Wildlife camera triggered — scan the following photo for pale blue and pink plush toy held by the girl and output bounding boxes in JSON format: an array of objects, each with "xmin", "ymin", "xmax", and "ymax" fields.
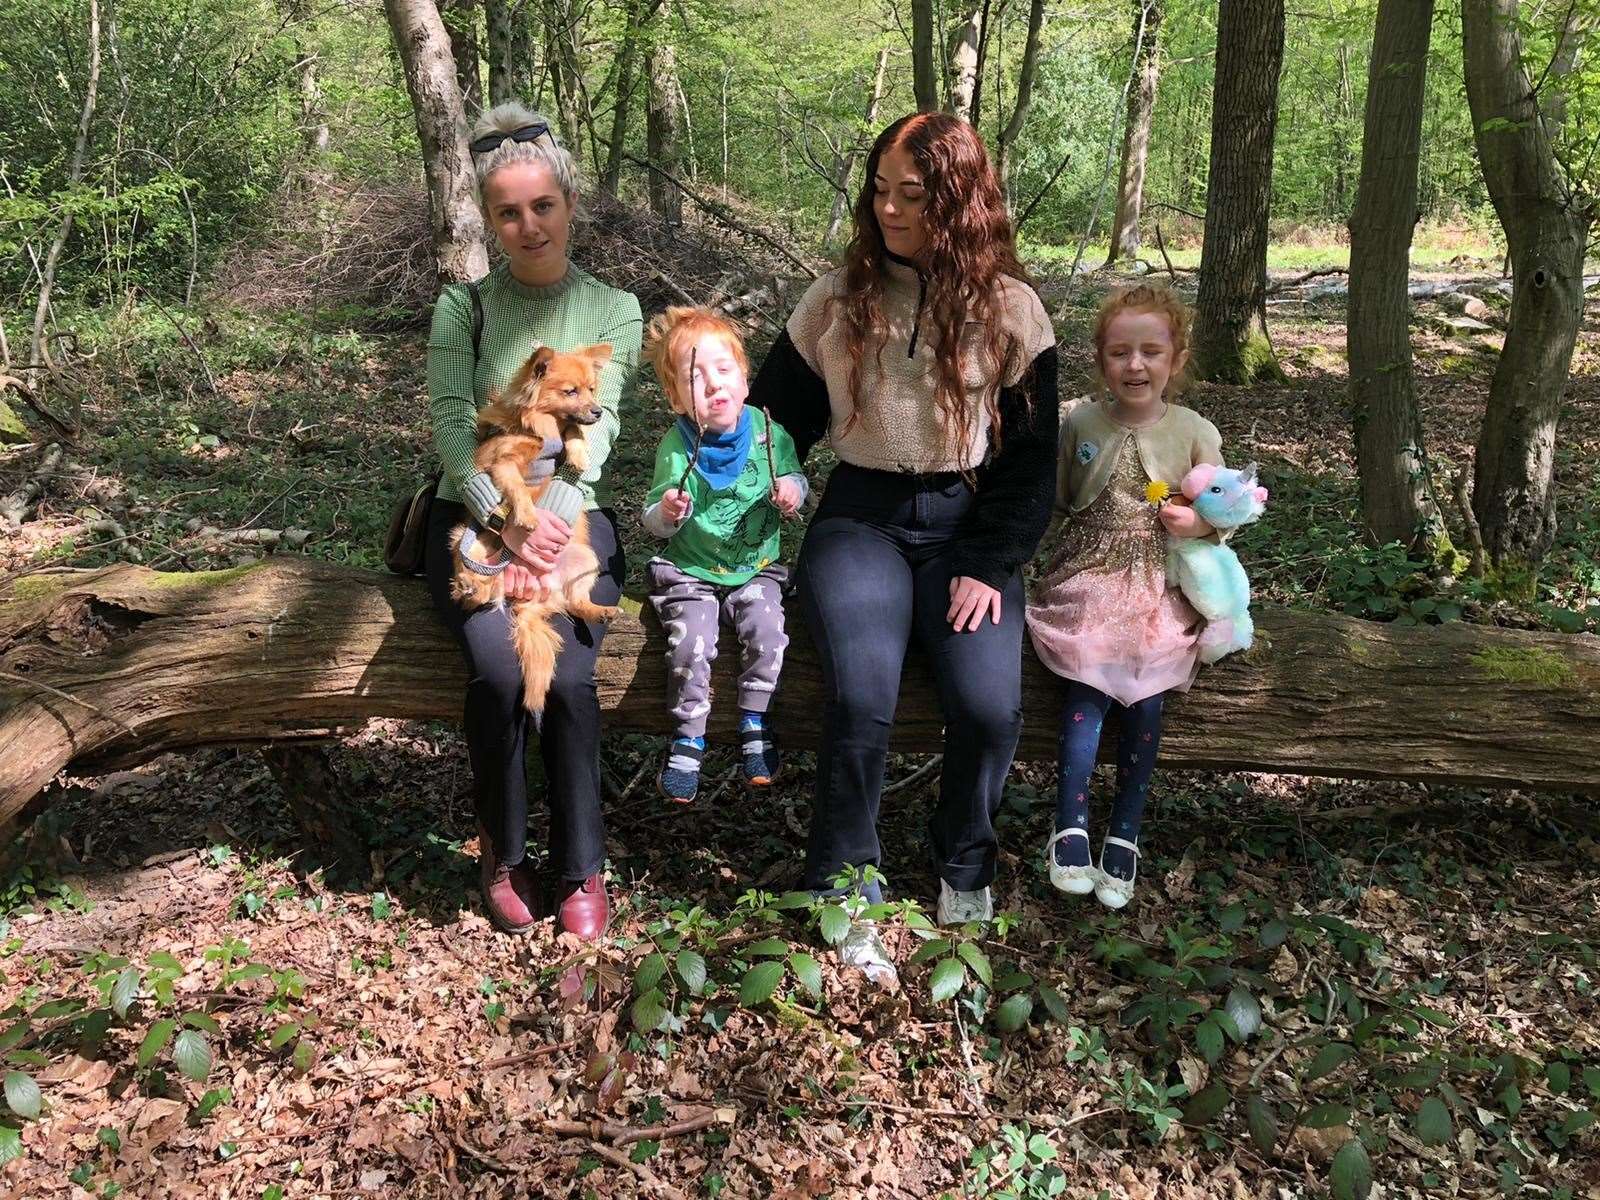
[{"xmin": 1166, "ymin": 462, "xmax": 1267, "ymax": 662}]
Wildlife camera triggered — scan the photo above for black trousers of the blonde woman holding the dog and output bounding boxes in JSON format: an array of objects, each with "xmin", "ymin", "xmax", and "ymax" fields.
[{"xmin": 427, "ymin": 499, "xmax": 627, "ymax": 880}]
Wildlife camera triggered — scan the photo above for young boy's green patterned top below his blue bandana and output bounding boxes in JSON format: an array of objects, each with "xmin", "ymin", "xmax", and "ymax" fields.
[{"xmin": 645, "ymin": 408, "xmax": 800, "ymax": 586}]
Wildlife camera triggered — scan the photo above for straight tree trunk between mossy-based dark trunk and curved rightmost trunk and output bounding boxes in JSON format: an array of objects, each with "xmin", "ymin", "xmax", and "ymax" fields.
[{"xmin": 1349, "ymin": 0, "xmax": 1440, "ymax": 549}]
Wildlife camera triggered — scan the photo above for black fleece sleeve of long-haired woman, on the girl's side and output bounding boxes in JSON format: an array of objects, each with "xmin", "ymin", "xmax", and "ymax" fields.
[{"xmin": 950, "ymin": 346, "xmax": 1061, "ymax": 587}]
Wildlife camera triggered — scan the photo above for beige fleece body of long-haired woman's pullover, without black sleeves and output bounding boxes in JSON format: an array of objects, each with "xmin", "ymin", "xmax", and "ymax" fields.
[{"xmin": 787, "ymin": 262, "xmax": 1056, "ymax": 474}]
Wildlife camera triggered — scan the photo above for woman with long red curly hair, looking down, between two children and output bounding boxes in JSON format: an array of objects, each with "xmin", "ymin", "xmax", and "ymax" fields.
[{"xmin": 750, "ymin": 114, "xmax": 1058, "ymax": 978}]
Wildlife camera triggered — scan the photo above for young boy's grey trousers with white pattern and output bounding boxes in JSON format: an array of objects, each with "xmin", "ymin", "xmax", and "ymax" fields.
[{"xmin": 645, "ymin": 558, "xmax": 789, "ymax": 738}]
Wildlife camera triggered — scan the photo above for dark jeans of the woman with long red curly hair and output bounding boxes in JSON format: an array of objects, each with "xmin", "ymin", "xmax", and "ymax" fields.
[{"xmin": 798, "ymin": 464, "xmax": 1022, "ymax": 891}]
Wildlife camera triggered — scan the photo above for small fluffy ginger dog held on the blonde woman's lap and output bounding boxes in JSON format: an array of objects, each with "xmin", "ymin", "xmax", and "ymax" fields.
[{"xmin": 450, "ymin": 342, "xmax": 618, "ymax": 712}]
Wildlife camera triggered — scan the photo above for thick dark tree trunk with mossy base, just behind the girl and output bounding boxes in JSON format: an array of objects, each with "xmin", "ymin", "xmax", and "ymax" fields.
[{"xmin": 1194, "ymin": 0, "xmax": 1283, "ymax": 384}]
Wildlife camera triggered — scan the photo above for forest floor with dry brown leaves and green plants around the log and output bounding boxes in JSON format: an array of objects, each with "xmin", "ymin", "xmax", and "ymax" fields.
[{"xmin": 0, "ymin": 227, "xmax": 1600, "ymax": 1200}]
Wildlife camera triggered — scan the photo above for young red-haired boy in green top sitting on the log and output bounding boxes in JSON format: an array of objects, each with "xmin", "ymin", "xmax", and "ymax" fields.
[{"xmin": 643, "ymin": 307, "xmax": 808, "ymax": 803}]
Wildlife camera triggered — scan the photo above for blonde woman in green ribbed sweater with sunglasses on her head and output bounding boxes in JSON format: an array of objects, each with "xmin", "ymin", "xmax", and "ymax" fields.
[{"xmin": 427, "ymin": 104, "xmax": 643, "ymax": 939}]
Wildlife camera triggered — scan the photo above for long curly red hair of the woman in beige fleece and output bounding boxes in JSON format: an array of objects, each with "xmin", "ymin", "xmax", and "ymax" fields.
[{"xmin": 840, "ymin": 112, "xmax": 1029, "ymax": 464}]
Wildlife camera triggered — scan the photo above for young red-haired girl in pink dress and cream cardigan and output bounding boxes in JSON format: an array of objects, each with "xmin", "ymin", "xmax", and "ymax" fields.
[{"xmin": 1027, "ymin": 285, "xmax": 1222, "ymax": 909}]
